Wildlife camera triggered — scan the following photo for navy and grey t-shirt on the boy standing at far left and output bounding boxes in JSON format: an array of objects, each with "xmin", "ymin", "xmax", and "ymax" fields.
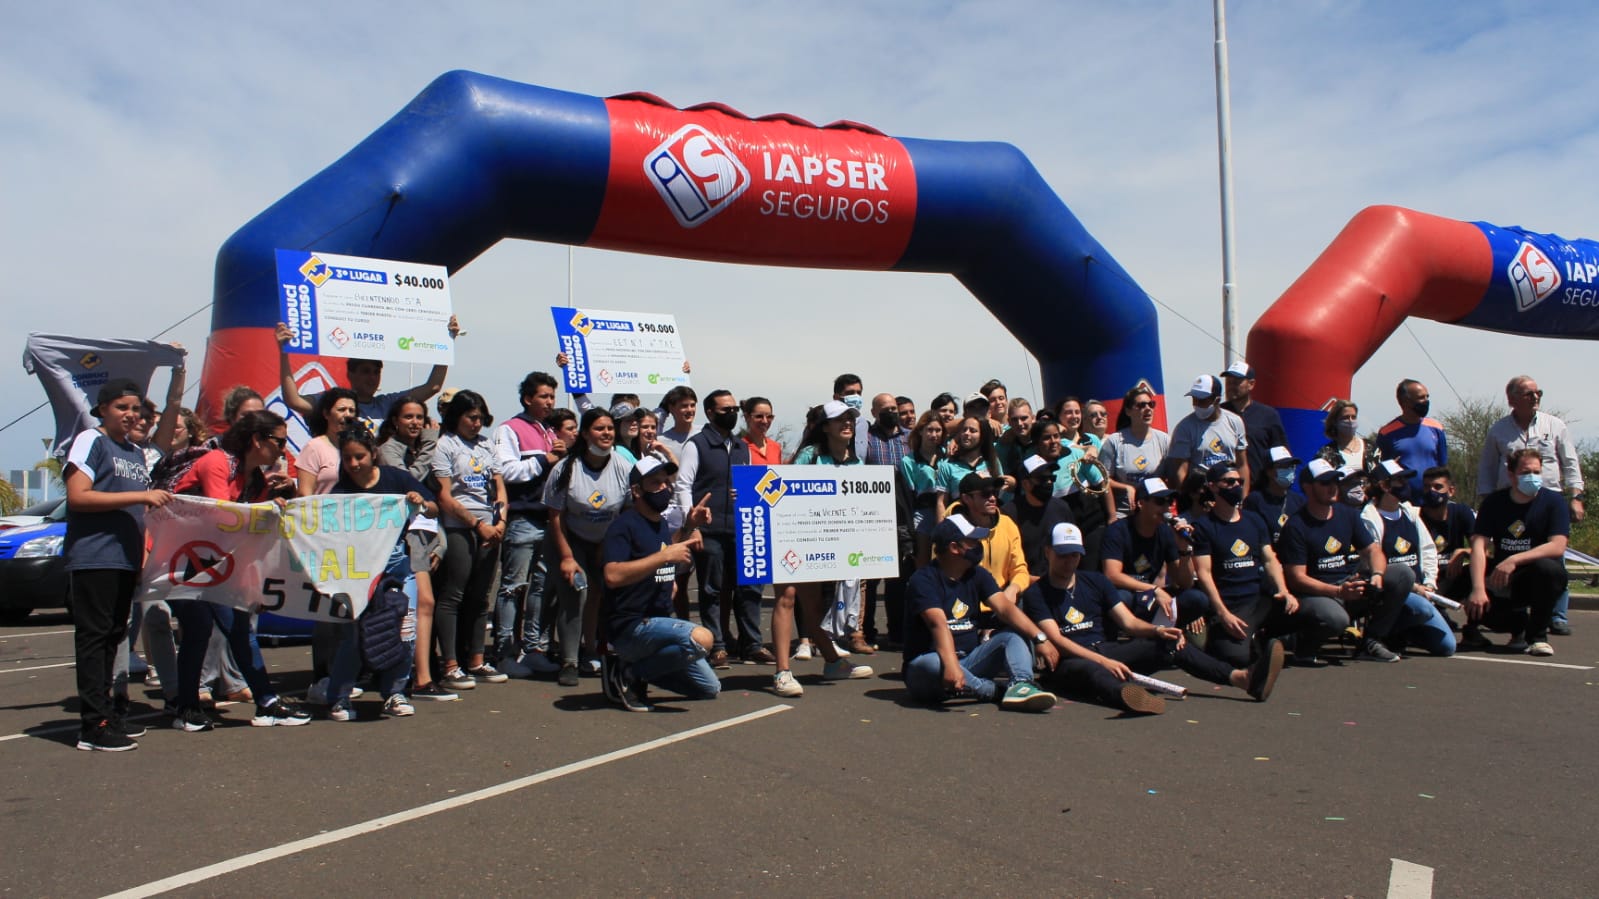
[{"xmin": 61, "ymin": 429, "xmax": 150, "ymax": 571}]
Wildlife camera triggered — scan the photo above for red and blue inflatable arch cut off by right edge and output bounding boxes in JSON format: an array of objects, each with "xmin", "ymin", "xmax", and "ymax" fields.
[{"xmin": 1249, "ymin": 206, "xmax": 1599, "ymax": 457}]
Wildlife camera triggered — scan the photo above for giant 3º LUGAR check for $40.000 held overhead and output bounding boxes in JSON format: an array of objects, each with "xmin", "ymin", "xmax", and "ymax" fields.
[{"xmin": 278, "ymin": 250, "xmax": 456, "ymax": 365}]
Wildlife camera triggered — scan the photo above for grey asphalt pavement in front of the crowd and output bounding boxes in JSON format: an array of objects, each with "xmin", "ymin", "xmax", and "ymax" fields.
[{"xmin": 0, "ymin": 609, "xmax": 1599, "ymax": 899}]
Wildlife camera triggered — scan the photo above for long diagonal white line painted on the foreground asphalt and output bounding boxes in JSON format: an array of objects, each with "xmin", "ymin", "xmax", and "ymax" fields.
[{"xmin": 106, "ymin": 705, "xmax": 792, "ymax": 899}]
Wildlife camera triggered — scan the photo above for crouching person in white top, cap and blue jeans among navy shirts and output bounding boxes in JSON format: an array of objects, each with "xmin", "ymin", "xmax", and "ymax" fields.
[{"xmin": 1361, "ymin": 459, "xmax": 1455, "ymax": 657}]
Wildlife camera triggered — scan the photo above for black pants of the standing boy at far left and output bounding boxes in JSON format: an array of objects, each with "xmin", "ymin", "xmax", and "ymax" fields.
[{"xmin": 67, "ymin": 568, "xmax": 135, "ymax": 728}]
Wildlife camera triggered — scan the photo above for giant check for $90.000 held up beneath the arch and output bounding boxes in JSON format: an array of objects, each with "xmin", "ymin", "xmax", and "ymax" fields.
[{"xmin": 550, "ymin": 306, "xmax": 689, "ymax": 394}]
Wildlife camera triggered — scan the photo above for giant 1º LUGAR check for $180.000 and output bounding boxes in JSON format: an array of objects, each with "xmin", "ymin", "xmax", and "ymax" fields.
[{"xmin": 732, "ymin": 465, "xmax": 899, "ymax": 584}]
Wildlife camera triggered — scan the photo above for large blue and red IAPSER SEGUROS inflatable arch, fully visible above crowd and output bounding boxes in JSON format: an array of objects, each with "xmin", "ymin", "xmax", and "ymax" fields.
[{"xmin": 201, "ymin": 72, "xmax": 1162, "ymax": 435}]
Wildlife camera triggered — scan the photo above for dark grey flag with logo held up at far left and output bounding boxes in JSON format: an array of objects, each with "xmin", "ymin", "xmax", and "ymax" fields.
[{"xmin": 22, "ymin": 333, "xmax": 184, "ymax": 457}]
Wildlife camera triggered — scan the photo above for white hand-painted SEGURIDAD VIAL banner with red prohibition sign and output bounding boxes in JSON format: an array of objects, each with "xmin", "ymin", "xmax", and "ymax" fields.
[{"xmin": 139, "ymin": 493, "xmax": 413, "ymax": 621}]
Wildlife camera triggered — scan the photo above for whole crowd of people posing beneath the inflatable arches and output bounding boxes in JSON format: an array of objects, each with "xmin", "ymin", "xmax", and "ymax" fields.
[{"xmin": 64, "ymin": 320, "xmax": 1583, "ymax": 750}]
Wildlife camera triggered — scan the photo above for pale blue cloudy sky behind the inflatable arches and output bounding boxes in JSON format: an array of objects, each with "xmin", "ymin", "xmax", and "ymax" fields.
[{"xmin": 0, "ymin": 0, "xmax": 1599, "ymax": 469}]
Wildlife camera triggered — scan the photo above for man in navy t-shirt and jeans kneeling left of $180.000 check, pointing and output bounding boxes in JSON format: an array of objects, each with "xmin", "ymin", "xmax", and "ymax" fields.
[{"xmin": 600, "ymin": 454, "xmax": 716, "ymax": 712}]
